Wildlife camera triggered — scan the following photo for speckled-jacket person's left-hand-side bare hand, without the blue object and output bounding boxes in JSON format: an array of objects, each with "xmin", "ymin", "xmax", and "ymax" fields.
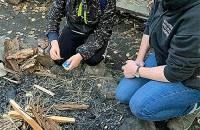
[{"xmin": 50, "ymin": 40, "xmax": 61, "ymax": 60}]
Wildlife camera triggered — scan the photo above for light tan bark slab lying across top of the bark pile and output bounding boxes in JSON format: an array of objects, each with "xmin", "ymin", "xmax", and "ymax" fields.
[{"xmin": 6, "ymin": 48, "xmax": 38, "ymax": 60}]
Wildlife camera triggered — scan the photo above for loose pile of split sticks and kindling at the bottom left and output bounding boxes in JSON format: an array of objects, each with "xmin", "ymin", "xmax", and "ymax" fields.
[{"xmin": 4, "ymin": 85, "xmax": 89, "ymax": 130}]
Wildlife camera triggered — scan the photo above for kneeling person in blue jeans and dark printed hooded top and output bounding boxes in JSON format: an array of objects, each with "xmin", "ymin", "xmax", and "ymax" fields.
[{"xmin": 116, "ymin": 0, "xmax": 200, "ymax": 130}]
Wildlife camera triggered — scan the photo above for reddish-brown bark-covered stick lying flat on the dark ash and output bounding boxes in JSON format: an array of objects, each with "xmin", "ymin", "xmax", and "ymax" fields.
[{"xmin": 54, "ymin": 103, "xmax": 89, "ymax": 111}]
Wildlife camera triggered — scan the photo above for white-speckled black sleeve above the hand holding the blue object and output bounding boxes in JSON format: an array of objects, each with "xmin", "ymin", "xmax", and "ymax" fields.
[{"xmin": 77, "ymin": 0, "xmax": 116, "ymax": 60}]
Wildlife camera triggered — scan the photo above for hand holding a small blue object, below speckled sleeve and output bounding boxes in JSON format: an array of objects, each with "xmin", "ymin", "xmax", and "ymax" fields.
[{"xmin": 66, "ymin": 53, "xmax": 83, "ymax": 71}]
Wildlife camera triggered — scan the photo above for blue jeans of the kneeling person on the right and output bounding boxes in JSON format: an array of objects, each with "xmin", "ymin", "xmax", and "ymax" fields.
[{"xmin": 116, "ymin": 54, "xmax": 200, "ymax": 121}]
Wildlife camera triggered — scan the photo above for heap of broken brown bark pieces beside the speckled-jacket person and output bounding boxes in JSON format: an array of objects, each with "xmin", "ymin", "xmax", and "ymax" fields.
[{"xmin": 1, "ymin": 38, "xmax": 54, "ymax": 80}]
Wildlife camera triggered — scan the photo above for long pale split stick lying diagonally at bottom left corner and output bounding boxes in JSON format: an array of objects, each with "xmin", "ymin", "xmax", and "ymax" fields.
[{"xmin": 10, "ymin": 100, "xmax": 43, "ymax": 130}]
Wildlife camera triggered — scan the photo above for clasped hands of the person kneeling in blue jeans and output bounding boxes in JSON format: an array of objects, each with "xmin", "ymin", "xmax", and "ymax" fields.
[{"xmin": 122, "ymin": 60, "xmax": 138, "ymax": 78}]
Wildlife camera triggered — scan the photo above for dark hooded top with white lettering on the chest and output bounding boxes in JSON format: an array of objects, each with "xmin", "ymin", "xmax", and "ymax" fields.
[{"xmin": 144, "ymin": 0, "xmax": 200, "ymax": 89}]
